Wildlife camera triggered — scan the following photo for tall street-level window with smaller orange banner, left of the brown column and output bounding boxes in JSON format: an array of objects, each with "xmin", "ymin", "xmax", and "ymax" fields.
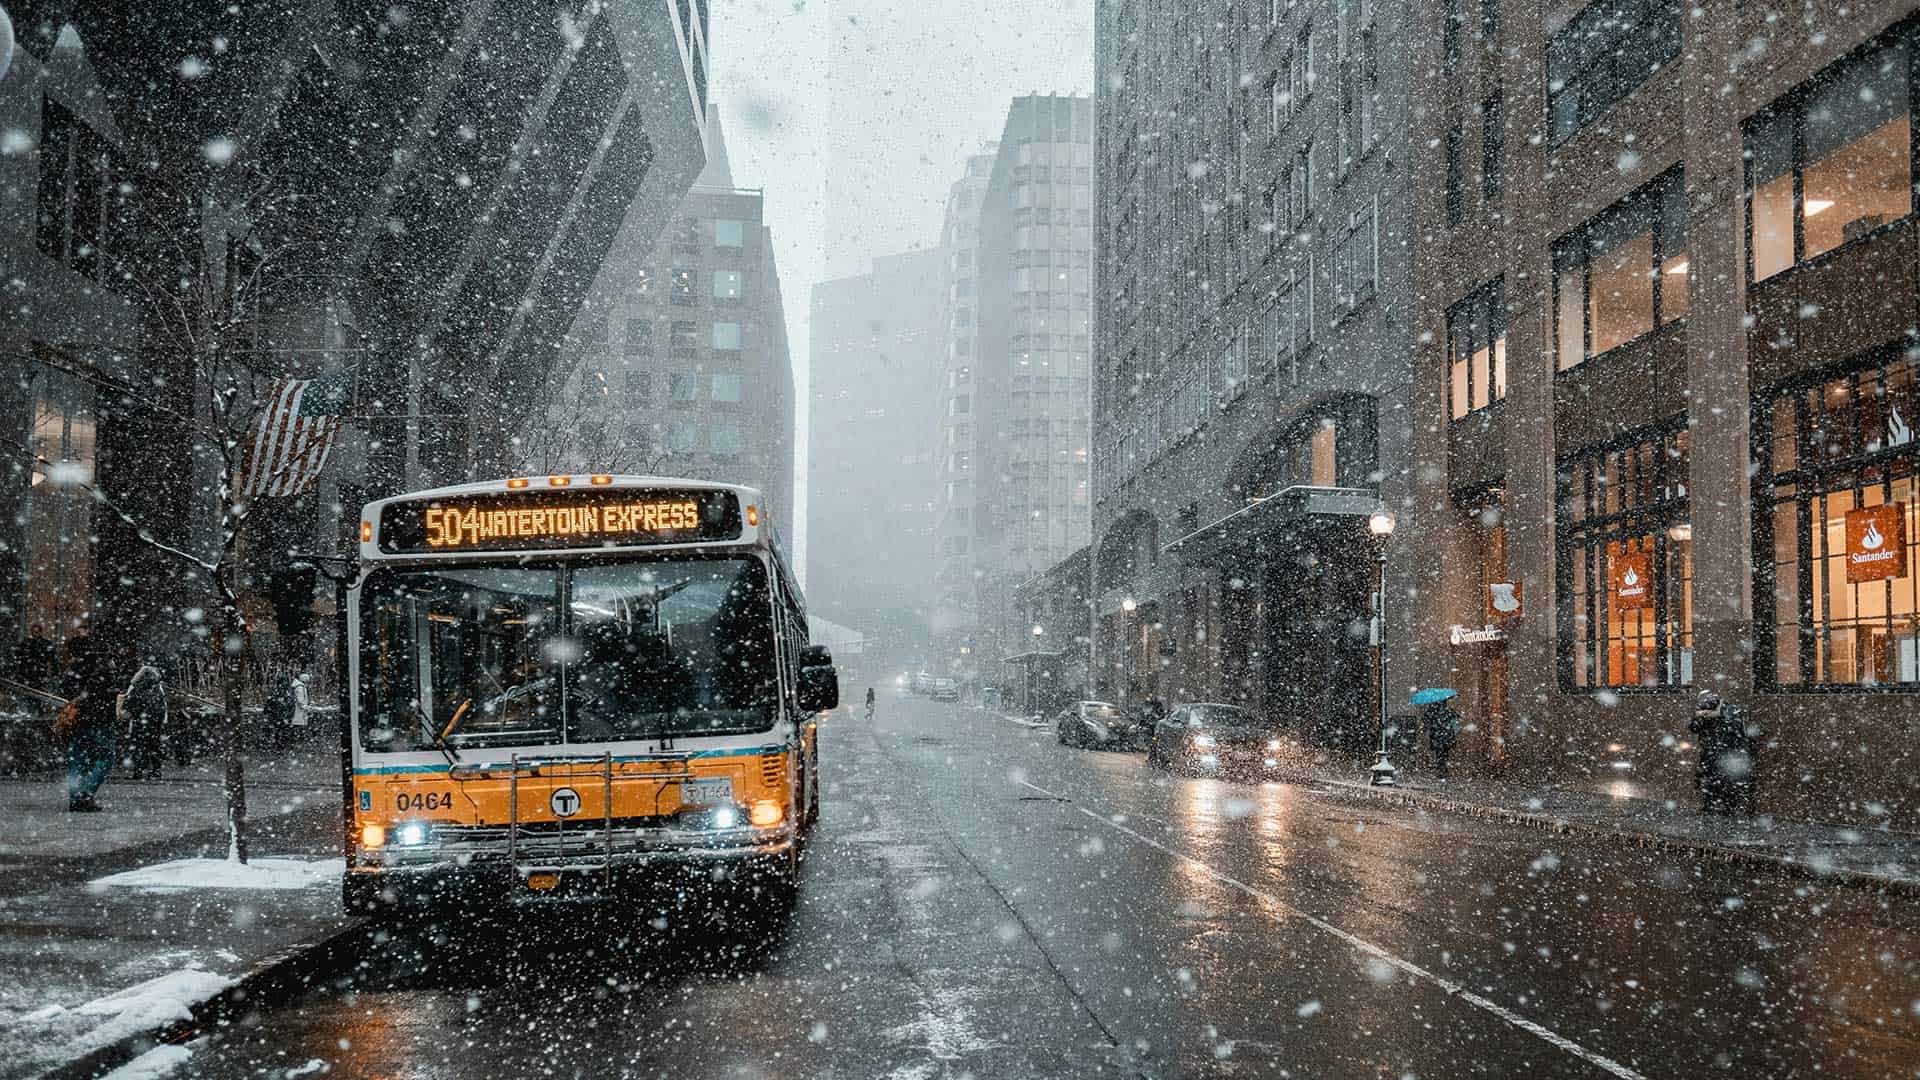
[{"xmin": 1555, "ymin": 427, "xmax": 1693, "ymax": 690}]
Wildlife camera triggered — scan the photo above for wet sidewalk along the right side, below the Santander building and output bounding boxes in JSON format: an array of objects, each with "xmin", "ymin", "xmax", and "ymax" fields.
[{"xmin": 1308, "ymin": 769, "xmax": 1920, "ymax": 894}]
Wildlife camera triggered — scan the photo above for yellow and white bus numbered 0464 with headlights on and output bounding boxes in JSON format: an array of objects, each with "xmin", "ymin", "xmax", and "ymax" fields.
[{"xmin": 342, "ymin": 475, "xmax": 839, "ymax": 911}]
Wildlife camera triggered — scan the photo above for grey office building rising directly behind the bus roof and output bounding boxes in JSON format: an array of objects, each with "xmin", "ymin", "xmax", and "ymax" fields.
[{"xmin": 526, "ymin": 110, "xmax": 793, "ymax": 534}]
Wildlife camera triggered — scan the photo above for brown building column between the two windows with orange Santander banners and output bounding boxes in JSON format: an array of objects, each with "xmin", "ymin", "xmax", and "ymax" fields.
[{"xmin": 1682, "ymin": 0, "xmax": 1753, "ymax": 700}]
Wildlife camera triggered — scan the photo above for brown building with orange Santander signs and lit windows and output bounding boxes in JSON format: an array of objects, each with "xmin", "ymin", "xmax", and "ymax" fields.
[{"xmin": 1394, "ymin": 0, "xmax": 1920, "ymax": 828}]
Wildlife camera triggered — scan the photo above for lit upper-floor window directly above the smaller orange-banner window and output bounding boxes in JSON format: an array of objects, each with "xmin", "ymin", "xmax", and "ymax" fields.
[{"xmin": 1553, "ymin": 167, "xmax": 1692, "ymax": 371}]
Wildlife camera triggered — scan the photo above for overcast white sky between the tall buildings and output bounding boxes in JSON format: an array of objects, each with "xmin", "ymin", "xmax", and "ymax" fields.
[{"xmin": 710, "ymin": 0, "xmax": 1092, "ymax": 575}]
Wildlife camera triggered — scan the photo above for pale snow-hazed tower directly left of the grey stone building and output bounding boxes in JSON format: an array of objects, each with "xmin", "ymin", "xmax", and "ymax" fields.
[{"xmin": 960, "ymin": 94, "xmax": 1092, "ymax": 678}]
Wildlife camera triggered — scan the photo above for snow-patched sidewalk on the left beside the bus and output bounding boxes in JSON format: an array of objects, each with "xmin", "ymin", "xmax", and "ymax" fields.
[{"xmin": 0, "ymin": 748, "xmax": 348, "ymax": 1080}]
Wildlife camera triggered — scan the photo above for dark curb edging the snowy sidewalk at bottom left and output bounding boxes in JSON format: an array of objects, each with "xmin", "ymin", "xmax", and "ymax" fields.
[{"xmin": 36, "ymin": 920, "xmax": 372, "ymax": 1080}]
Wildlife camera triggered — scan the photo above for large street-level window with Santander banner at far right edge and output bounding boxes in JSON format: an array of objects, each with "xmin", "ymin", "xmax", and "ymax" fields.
[{"xmin": 1753, "ymin": 352, "xmax": 1920, "ymax": 692}]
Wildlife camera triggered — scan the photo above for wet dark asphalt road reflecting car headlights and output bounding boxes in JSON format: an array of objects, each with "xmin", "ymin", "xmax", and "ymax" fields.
[{"xmin": 188, "ymin": 698, "xmax": 1920, "ymax": 1080}]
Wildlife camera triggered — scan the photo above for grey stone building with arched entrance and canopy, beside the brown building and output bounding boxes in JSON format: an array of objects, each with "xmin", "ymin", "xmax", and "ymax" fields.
[{"xmin": 1091, "ymin": 0, "xmax": 1411, "ymax": 734}]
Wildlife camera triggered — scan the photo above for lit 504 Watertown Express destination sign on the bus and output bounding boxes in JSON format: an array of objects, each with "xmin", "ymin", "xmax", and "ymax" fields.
[{"xmin": 380, "ymin": 488, "xmax": 741, "ymax": 553}]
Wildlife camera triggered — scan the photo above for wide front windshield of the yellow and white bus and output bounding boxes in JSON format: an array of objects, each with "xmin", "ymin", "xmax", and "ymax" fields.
[{"xmin": 359, "ymin": 557, "xmax": 780, "ymax": 751}]
